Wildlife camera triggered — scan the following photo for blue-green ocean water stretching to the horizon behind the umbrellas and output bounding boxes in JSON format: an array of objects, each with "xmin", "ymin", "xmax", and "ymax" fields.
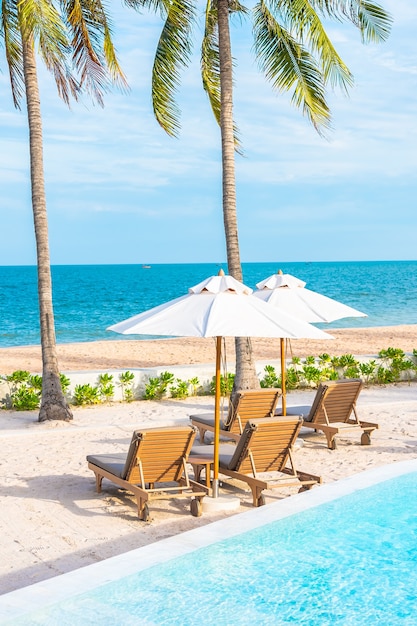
[{"xmin": 0, "ymin": 261, "xmax": 417, "ymax": 347}]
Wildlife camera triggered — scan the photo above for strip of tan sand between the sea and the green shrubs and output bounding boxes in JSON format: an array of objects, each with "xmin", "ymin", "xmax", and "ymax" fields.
[{"xmin": 0, "ymin": 324, "xmax": 417, "ymax": 375}]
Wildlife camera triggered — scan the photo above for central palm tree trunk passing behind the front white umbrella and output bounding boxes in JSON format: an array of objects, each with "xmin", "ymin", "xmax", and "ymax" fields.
[{"xmin": 217, "ymin": 0, "xmax": 259, "ymax": 391}]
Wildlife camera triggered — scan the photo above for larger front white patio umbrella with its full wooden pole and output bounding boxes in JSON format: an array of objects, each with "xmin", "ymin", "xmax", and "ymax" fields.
[{"xmin": 107, "ymin": 270, "xmax": 330, "ymax": 497}]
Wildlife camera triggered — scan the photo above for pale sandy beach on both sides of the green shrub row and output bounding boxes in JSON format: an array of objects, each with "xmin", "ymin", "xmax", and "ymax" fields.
[{"xmin": 0, "ymin": 326, "xmax": 417, "ymax": 593}]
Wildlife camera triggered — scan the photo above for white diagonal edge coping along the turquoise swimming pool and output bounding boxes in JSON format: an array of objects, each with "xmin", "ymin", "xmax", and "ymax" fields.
[{"xmin": 0, "ymin": 459, "xmax": 417, "ymax": 622}]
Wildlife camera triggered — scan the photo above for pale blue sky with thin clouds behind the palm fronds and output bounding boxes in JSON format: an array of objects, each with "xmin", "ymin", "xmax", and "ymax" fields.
[{"xmin": 0, "ymin": 0, "xmax": 417, "ymax": 265}]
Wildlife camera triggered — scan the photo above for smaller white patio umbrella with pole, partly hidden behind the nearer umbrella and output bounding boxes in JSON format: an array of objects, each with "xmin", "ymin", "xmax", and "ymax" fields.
[{"xmin": 253, "ymin": 270, "xmax": 366, "ymax": 415}]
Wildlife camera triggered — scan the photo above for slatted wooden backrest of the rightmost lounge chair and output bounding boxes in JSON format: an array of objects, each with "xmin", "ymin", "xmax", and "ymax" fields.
[{"xmin": 309, "ymin": 378, "xmax": 362, "ymax": 424}]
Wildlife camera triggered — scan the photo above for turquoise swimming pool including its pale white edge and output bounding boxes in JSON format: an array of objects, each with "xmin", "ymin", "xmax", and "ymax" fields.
[{"xmin": 0, "ymin": 461, "xmax": 417, "ymax": 626}]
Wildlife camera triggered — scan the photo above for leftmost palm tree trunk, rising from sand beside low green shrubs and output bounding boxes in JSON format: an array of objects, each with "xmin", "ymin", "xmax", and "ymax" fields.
[{"xmin": 22, "ymin": 32, "xmax": 72, "ymax": 422}]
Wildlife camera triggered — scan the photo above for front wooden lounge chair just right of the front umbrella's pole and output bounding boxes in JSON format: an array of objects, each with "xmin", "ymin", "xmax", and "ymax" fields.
[{"xmin": 188, "ymin": 417, "xmax": 322, "ymax": 506}]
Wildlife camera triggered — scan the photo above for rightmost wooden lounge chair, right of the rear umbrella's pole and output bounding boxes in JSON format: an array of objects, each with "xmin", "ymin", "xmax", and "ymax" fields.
[{"xmin": 287, "ymin": 378, "xmax": 378, "ymax": 450}]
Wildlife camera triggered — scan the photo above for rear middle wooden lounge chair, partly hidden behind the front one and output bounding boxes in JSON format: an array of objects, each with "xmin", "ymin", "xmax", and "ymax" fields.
[{"xmin": 190, "ymin": 389, "xmax": 282, "ymax": 443}]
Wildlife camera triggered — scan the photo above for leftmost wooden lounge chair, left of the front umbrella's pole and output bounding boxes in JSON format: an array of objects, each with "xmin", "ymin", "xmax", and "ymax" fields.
[{"xmin": 87, "ymin": 426, "xmax": 208, "ymax": 521}]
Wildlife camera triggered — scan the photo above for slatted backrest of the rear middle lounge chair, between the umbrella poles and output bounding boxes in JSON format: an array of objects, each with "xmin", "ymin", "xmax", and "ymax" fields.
[{"xmin": 226, "ymin": 389, "xmax": 282, "ymax": 434}]
